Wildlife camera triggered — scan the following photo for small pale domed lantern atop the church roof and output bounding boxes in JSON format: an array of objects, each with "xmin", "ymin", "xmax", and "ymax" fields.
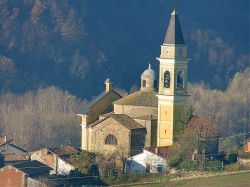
[{"xmin": 141, "ymin": 64, "xmax": 157, "ymax": 91}]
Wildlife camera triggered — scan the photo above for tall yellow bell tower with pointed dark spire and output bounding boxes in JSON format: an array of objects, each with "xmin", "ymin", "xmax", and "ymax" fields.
[{"xmin": 157, "ymin": 10, "xmax": 188, "ymax": 147}]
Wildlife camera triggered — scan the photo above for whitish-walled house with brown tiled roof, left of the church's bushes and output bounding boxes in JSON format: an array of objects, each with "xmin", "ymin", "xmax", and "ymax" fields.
[{"xmin": 30, "ymin": 146, "xmax": 79, "ymax": 175}]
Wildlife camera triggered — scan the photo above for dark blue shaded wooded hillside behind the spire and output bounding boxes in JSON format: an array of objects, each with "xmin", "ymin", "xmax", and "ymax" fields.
[{"xmin": 0, "ymin": 0, "xmax": 250, "ymax": 99}]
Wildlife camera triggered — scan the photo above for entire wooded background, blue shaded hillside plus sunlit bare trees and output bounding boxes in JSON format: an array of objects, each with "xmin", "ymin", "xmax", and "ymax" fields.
[{"xmin": 0, "ymin": 0, "xmax": 250, "ymax": 150}]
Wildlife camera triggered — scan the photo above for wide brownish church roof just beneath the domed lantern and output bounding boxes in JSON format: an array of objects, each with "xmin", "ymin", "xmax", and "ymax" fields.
[{"xmin": 113, "ymin": 91, "xmax": 158, "ymax": 107}]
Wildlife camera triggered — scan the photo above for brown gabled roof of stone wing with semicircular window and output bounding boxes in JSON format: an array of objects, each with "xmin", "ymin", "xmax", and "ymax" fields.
[{"xmin": 88, "ymin": 113, "xmax": 145, "ymax": 130}]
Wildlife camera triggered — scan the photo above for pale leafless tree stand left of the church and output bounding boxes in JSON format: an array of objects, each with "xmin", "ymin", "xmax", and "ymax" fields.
[{"xmin": 0, "ymin": 87, "xmax": 86, "ymax": 149}]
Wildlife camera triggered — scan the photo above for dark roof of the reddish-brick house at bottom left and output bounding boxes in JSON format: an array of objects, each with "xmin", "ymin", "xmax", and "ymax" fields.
[{"xmin": 12, "ymin": 160, "xmax": 52, "ymax": 177}]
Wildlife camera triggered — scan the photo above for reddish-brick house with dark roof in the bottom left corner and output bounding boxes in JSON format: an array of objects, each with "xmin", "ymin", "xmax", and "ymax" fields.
[{"xmin": 0, "ymin": 161, "xmax": 51, "ymax": 187}]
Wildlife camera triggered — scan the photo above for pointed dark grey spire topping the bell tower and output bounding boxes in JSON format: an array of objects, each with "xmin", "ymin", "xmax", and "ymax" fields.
[{"xmin": 163, "ymin": 10, "xmax": 185, "ymax": 44}]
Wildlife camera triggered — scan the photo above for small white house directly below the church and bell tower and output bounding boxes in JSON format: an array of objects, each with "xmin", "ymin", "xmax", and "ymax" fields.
[{"xmin": 126, "ymin": 149, "xmax": 168, "ymax": 173}]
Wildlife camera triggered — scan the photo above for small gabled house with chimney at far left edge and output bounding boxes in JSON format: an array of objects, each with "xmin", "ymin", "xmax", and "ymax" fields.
[{"xmin": 0, "ymin": 136, "xmax": 29, "ymax": 166}]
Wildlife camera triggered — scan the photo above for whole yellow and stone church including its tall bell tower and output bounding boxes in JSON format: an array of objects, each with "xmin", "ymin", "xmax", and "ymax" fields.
[{"xmin": 78, "ymin": 10, "xmax": 189, "ymax": 157}]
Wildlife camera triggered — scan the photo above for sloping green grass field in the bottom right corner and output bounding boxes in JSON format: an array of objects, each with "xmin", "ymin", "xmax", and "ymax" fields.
[{"xmin": 133, "ymin": 172, "xmax": 250, "ymax": 187}]
